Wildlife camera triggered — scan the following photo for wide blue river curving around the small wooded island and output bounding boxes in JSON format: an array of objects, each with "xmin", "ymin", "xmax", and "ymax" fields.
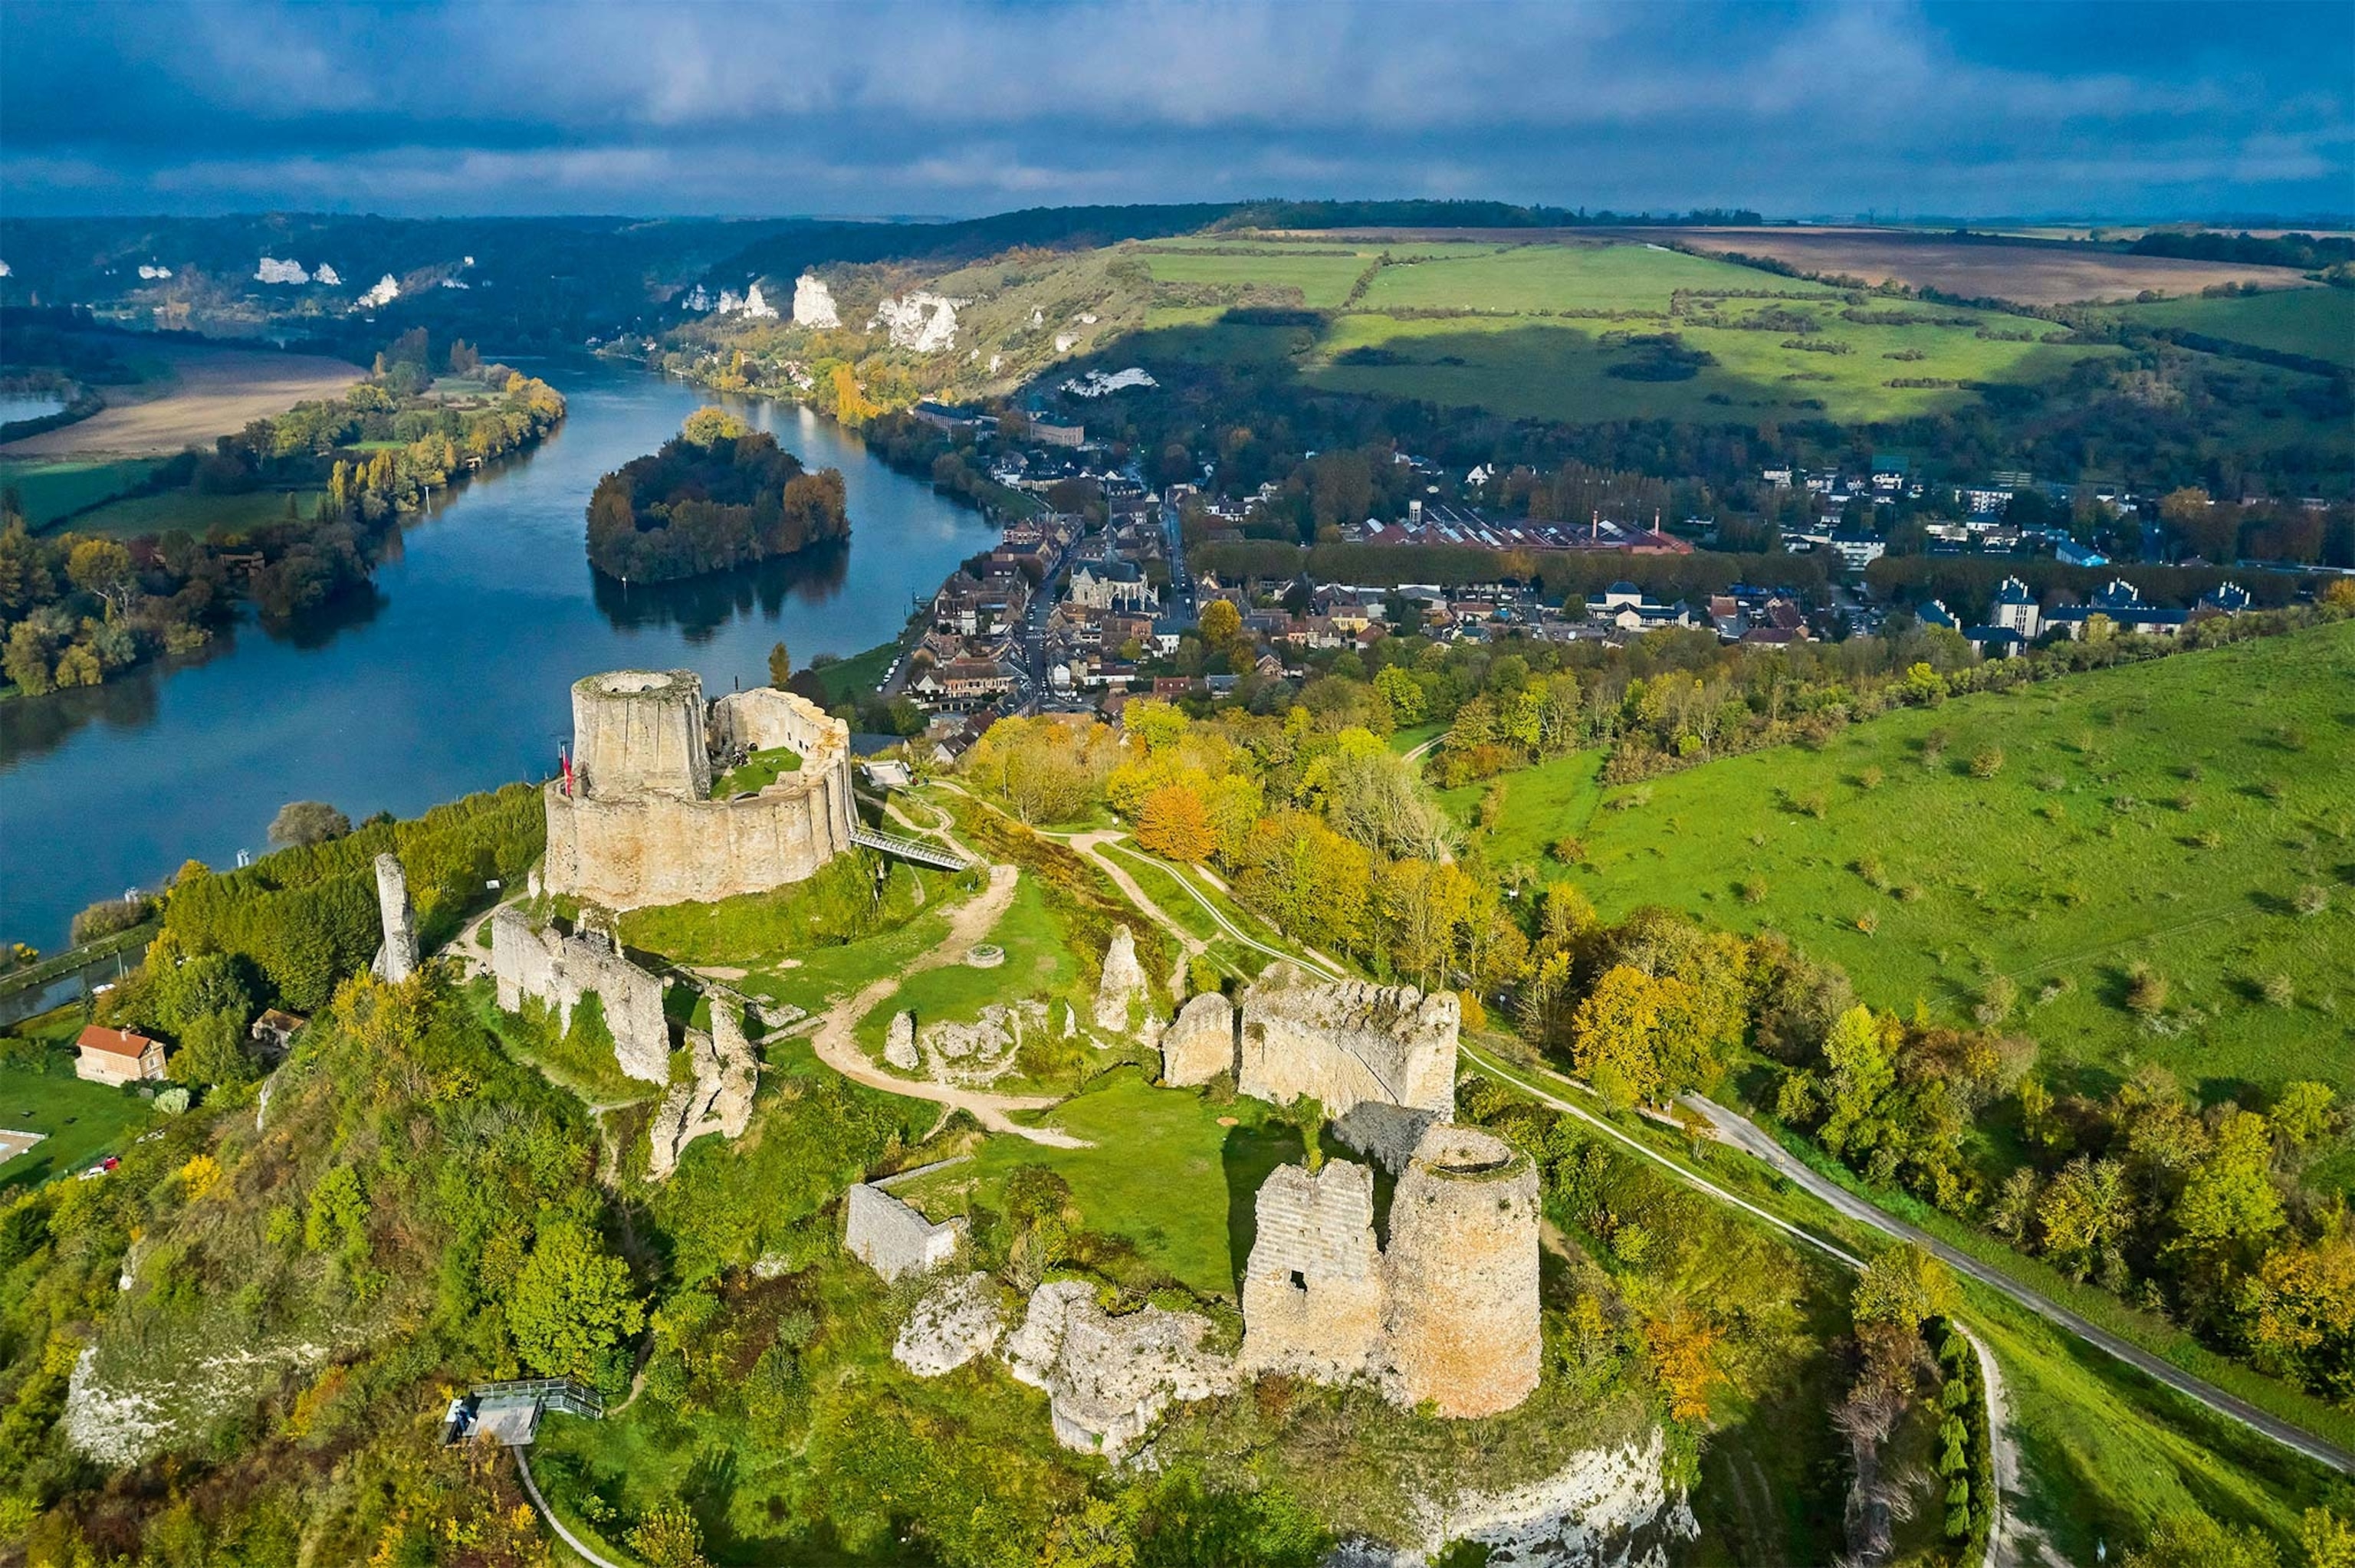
[{"xmin": 0, "ymin": 360, "xmax": 994, "ymax": 949}]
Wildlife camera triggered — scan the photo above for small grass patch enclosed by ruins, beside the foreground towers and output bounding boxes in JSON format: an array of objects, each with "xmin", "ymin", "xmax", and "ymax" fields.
[{"xmin": 892, "ymin": 1067, "xmax": 1300, "ymax": 1297}]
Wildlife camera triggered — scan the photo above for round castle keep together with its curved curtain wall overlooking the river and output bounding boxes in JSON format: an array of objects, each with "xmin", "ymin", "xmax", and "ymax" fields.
[{"xmin": 542, "ymin": 668, "xmax": 852, "ymax": 909}]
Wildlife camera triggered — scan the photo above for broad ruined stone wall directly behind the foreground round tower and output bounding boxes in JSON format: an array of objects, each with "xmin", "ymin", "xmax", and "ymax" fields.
[{"xmin": 1237, "ymin": 966, "xmax": 1460, "ymax": 1120}]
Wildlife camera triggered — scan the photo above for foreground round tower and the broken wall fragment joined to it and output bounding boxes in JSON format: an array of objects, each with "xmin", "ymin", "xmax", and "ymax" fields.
[{"xmin": 1239, "ymin": 1123, "xmax": 1540, "ymax": 1417}]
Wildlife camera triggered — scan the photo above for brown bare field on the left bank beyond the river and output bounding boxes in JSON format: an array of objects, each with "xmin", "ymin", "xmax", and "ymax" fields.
[{"xmin": 0, "ymin": 339, "xmax": 360, "ymax": 457}]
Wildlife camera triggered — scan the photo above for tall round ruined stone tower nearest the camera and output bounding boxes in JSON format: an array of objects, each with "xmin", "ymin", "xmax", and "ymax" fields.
[{"xmin": 1382, "ymin": 1123, "xmax": 1540, "ymax": 1417}]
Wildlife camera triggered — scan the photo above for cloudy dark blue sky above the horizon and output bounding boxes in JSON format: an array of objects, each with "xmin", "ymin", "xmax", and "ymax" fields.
[{"xmin": 0, "ymin": 0, "xmax": 2355, "ymax": 219}]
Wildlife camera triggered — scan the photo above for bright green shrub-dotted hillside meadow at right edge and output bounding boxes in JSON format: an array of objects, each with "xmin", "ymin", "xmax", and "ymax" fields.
[{"xmin": 1545, "ymin": 624, "xmax": 2355, "ymax": 1100}]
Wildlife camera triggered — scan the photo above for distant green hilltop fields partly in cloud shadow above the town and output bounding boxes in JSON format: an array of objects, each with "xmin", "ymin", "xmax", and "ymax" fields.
[{"xmin": 1102, "ymin": 240, "xmax": 2107, "ymax": 422}]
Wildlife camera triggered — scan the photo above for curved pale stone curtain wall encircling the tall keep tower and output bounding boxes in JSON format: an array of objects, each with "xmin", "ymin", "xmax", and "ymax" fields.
[{"xmin": 542, "ymin": 676, "xmax": 852, "ymax": 909}]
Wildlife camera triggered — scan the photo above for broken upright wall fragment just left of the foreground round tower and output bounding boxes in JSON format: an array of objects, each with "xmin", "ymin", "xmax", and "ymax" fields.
[{"xmin": 1241, "ymin": 1161, "xmax": 1382, "ymax": 1382}]
